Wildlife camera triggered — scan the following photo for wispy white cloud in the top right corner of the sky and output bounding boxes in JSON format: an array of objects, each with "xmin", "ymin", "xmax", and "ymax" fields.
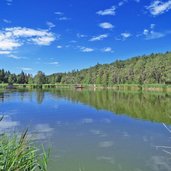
[{"xmin": 146, "ymin": 0, "xmax": 171, "ymax": 16}]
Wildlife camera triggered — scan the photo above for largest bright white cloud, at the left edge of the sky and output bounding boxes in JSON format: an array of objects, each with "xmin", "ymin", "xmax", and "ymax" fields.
[{"xmin": 0, "ymin": 27, "xmax": 56, "ymax": 54}]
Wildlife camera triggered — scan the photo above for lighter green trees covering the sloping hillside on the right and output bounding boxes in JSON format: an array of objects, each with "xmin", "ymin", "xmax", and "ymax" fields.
[{"xmin": 48, "ymin": 52, "xmax": 171, "ymax": 86}]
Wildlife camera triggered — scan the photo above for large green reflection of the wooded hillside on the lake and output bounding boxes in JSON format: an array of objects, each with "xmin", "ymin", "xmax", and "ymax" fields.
[{"xmin": 50, "ymin": 89, "xmax": 171, "ymax": 124}]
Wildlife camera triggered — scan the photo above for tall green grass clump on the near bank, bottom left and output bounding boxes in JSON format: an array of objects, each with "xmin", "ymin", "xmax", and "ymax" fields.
[{"xmin": 0, "ymin": 119, "xmax": 49, "ymax": 171}]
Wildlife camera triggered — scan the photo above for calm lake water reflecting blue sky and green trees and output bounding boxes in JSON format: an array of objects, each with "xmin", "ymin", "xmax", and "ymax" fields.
[{"xmin": 0, "ymin": 89, "xmax": 171, "ymax": 171}]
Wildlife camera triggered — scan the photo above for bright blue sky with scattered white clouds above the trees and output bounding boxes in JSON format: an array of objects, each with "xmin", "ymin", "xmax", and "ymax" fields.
[{"xmin": 0, "ymin": 0, "xmax": 171, "ymax": 74}]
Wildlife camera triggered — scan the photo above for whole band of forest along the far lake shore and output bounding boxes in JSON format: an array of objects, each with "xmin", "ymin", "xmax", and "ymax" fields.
[{"xmin": 0, "ymin": 52, "xmax": 171, "ymax": 86}]
